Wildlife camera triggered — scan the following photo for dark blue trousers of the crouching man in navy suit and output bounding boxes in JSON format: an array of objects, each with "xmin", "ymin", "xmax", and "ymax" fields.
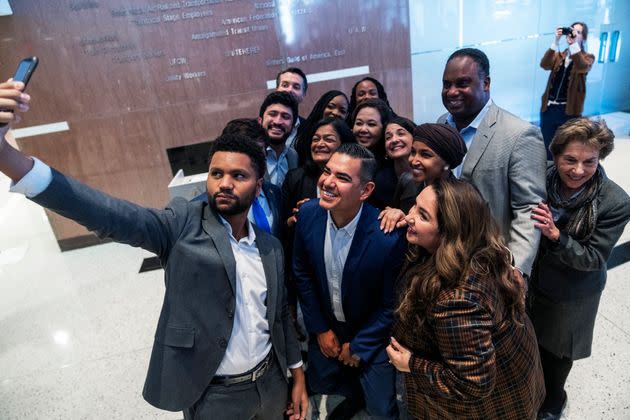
[{"xmin": 306, "ymin": 328, "xmax": 398, "ymax": 419}]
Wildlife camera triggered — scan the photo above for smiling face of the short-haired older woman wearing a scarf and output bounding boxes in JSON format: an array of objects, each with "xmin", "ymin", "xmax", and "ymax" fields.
[{"xmin": 553, "ymin": 140, "xmax": 599, "ymax": 196}]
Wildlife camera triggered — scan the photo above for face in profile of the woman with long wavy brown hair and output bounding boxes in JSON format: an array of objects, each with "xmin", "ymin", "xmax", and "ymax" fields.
[{"xmin": 405, "ymin": 187, "xmax": 440, "ymax": 254}]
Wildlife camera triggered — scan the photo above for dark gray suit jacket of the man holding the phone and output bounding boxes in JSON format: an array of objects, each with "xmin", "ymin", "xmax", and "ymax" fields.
[{"xmin": 33, "ymin": 170, "xmax": 301, "ymax": 411}]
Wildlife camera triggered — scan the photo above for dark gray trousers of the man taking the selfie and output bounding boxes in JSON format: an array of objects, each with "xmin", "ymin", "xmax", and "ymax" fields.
[{"xmin": 184, "ymin": 363, "xmax": 288, "ymax": 420}]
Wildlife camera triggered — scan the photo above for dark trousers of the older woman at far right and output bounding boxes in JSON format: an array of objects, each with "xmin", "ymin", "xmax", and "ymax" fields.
[{"xmin": 538, "ymin": 347, "xmax": 573, "ymax": 414}]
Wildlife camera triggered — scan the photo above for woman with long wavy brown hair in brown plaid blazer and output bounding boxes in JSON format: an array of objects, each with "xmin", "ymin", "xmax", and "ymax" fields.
[{"xmin": 387, "ymin": 178, "xmax": 545, "ymax": 420}]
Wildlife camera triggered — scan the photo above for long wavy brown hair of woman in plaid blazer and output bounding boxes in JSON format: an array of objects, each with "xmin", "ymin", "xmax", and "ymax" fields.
[{"xmin": 396, "ymin": 178, "xmax": 525, "ymax": 325}]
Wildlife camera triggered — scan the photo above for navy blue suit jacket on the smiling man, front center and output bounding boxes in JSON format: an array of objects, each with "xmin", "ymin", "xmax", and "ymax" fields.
[{"xmin": 293, "ymin": 200, "xmax": 406, "ymax": 363}]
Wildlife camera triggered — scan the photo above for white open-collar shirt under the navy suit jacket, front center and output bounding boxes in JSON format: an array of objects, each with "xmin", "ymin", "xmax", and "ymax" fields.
[{"xmin": 324, "ymin": 205, "xmax": 363, "ymax": 322}]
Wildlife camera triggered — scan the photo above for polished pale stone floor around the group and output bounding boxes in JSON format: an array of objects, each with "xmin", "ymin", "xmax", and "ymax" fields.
[{"xmin": 0, "ymin": 113, "xmax": 630, "ymax": 420}]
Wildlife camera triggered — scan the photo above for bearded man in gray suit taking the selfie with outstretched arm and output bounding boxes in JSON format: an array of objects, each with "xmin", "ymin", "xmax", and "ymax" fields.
[{"xmin": 0, "ymin": 82, "xmax": 308, "ymax": 420}]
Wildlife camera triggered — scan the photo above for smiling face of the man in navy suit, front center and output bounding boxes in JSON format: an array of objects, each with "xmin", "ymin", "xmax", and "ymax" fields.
[{"xmin": 317, "ymin": 153, "xmax": 374, "ymax": 220}]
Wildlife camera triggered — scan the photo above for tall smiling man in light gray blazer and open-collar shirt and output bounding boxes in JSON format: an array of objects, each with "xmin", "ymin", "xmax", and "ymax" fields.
[{"xmin": 438, "ymin": 48, "xmax": 546, "ymax": 275}]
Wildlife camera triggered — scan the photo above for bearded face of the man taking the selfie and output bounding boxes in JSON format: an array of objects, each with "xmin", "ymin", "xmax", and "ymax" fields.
[{"xmin": 206, "ymin": 152, "xmax": 262, "ymax": 216}]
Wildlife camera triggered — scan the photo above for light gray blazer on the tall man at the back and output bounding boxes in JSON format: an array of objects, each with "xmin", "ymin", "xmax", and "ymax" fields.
[{"xmin": 438, "ymin": 103, "xmax": 547, "ymax": 274}]
